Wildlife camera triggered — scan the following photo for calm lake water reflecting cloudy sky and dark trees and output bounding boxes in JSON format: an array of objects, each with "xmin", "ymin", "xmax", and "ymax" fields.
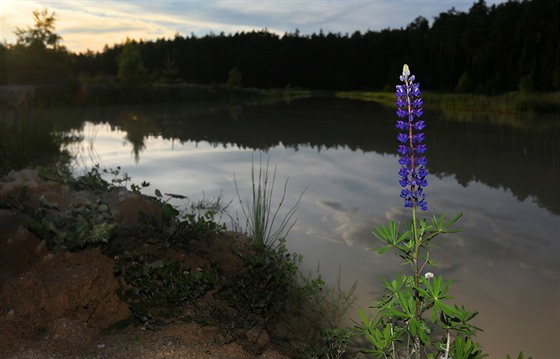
[{"xmin": 2, "ymin": 98, "xmax": 560, "ymax": 358}]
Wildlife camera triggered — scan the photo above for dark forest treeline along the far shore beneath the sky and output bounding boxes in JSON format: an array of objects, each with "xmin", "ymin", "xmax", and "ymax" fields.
[{"xmin": 0, "ymin": 0, "xmax": 560, "ymax": 95}]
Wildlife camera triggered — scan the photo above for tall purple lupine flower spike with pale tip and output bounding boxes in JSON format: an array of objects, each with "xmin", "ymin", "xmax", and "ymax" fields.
[{"xmin": 395, "ymin": 65, "xmax": 428, "ymax": 211}]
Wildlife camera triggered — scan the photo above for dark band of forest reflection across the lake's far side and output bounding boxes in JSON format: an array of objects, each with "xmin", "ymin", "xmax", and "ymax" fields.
[{"xmin": 59, "ymin": 98, "xmax": 560, "ymax": 214}]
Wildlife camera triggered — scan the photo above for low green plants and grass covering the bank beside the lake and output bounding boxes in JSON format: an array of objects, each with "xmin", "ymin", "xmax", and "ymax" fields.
[{"xmin": 3, "ymin": 165, "xmax": 354, "ymax": 358}]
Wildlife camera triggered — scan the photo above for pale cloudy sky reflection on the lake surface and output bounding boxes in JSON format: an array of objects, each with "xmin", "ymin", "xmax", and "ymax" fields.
[{"xmin": 71, "ymin": 112, "xmax": 560, "ymax": 356}]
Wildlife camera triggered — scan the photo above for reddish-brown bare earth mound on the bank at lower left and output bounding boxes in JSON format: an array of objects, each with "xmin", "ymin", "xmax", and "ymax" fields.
[{"xmin": 0, "ymin": 246, "xmax": 129, "ymax": 329}]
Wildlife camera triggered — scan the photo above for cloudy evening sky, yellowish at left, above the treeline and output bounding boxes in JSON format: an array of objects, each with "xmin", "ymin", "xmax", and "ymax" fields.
[{"xmin": 0, "ymin": 0, "xmax": 505, "ymax": 52}]
